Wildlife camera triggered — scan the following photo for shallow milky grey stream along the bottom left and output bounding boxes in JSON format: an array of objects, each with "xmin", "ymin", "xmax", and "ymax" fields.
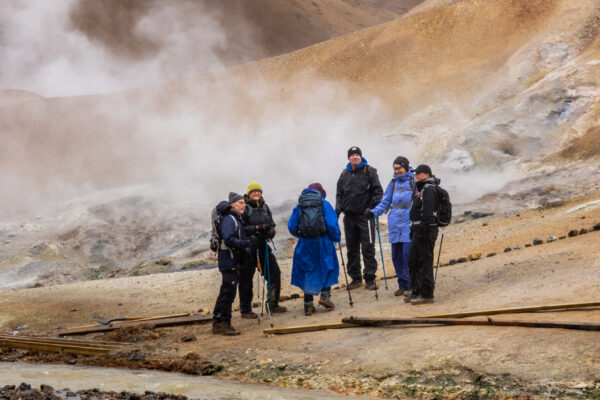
[{"xmin": 0, "ymin": 362, "xmax": 366, "ymax": 400}]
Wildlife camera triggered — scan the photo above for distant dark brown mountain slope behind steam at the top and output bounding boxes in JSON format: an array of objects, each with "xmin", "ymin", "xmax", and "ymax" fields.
[{"xmin": 71, "ymin": 0, "xmax": 422, "ymax": 63}]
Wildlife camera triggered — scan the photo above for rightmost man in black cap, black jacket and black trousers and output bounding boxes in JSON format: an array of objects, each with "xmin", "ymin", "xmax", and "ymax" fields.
[{"xmin": 404, "ymin": 165, "xmax": 440, "ymax": 304}]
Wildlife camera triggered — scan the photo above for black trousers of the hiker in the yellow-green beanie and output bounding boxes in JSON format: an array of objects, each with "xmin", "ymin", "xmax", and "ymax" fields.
[{"xmin": 240, "ymin": 241, "xmax": 281, "ymax": 314}]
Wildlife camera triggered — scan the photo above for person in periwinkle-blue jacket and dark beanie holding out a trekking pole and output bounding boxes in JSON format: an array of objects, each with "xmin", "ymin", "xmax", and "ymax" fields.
[{"xmin": 365, "ymin": 156, "xmax": 415, "ymax": 296}]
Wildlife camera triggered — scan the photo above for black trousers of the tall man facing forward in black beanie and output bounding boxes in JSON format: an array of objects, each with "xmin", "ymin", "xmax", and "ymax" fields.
[{"xmin": 344, "ymin": 214, "xmax": 377, "ymax": 281}]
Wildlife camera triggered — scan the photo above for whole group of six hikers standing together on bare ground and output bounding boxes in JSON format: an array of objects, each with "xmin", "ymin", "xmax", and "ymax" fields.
[{"xmin": 211, "ymin": 146, "xmax": 447, "ymax": 335}]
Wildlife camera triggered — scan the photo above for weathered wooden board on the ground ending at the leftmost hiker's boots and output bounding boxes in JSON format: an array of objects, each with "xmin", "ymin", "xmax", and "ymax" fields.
[{"xmin": 58, "ymin": 314, "xmax": 212, "ymax": 336}]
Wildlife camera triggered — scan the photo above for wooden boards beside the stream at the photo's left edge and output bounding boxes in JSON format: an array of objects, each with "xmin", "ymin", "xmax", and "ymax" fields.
[{"xmin": 0, "ymin": 335, "xmax": 123, "ymax": 356}]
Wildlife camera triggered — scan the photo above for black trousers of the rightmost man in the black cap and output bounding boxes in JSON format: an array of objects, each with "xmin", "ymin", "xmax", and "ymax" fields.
[{"xmin": 408, "ymin": 225, "xmax": 438, "ymax": 298}]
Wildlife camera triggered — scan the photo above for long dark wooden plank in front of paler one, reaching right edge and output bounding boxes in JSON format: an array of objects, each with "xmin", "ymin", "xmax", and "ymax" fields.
[{"xmin": 342, "ymin": 317, "xmax": 600, "ymax": 331}]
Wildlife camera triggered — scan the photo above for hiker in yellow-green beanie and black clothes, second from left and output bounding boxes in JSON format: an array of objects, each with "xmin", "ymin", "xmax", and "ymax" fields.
[{"xmin": 240, "ymin": 181, "xmax": 287, "ymax": 319}]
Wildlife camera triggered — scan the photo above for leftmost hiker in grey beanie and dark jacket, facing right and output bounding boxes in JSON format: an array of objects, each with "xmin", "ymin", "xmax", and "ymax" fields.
[{"xmin": 212, "ymin": 192, "xmax": 257, "ymax": 336}]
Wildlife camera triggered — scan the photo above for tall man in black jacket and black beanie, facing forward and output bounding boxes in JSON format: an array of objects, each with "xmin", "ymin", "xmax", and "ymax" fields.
[{"xmin": 335, "ymin": 146, "xmax": 383, "ymax": 290}]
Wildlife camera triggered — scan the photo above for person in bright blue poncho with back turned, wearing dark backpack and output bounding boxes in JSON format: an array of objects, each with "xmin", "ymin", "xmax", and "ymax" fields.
[{"xmin": 288, "ymin": 183, "xmax": 341, "ymax": 315}]
